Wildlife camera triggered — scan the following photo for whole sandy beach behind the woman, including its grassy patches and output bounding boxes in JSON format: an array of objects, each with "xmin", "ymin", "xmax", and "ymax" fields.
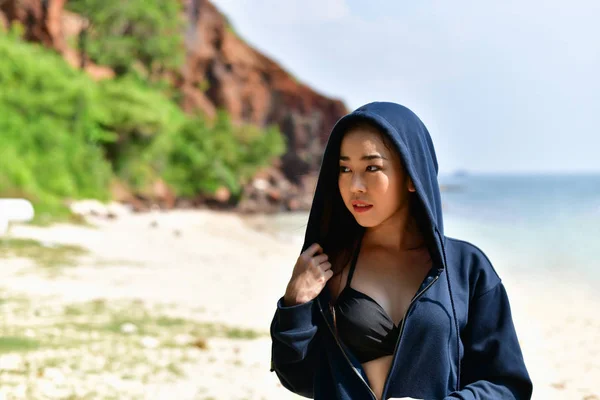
[{"xmin": 0, "ymin": 210, "xmax": 600, "ymax": 400}]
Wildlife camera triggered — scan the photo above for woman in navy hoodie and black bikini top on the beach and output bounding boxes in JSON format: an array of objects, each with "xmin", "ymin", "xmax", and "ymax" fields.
[{"xmin": 271, "ymin": 102, "xmax": 532, "ymax": 400}]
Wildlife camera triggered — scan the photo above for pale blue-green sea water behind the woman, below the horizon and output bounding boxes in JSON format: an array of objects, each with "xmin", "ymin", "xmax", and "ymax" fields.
[{"xmin": 254, "ymin": 174, "xmax": 600, "ymax": 283}]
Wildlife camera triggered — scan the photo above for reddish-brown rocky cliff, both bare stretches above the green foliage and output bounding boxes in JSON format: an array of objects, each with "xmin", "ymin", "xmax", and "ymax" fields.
[{"xmin": 0, "ymin": 0, "xmax": 346, "ymax": 212}]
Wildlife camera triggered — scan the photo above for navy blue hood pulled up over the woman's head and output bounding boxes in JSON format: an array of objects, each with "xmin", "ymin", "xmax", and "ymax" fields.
[{"xmin": 302, "ymin": 102, "xmax": 445, "ymax": 268}]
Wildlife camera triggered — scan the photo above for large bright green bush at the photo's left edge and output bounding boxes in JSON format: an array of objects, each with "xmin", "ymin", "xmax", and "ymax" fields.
[{"xmin": 0, "ymin": 35, "xmax": 113, "ymax": 212}]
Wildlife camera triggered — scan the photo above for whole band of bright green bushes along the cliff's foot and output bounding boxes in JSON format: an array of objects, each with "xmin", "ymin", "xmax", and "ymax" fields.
[{"xmin": 0, "ymin": 28, "xmax": 285, "ymax": 217}]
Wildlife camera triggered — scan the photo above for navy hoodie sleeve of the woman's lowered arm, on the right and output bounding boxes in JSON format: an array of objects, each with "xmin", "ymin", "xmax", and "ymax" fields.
[{"xmin": 444, "ymin": 282, "xmax": 532, "ymax": 400}]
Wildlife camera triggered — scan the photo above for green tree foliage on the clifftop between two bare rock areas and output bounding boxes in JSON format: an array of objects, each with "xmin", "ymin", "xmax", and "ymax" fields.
[{"xmin": 67, "ymin": 0, "xmax": 184, "ymax": 78}]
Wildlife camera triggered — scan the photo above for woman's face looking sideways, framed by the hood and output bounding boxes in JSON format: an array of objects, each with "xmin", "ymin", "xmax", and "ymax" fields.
[{"xmin": 338, "ymin": 127, "xmax": 414, "ymax": 228}]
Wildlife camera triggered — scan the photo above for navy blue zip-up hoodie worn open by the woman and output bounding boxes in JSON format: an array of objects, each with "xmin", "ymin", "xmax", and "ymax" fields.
[{"xmin": 271, "ymin": 102, "xmax": 532, "ymax": 400}]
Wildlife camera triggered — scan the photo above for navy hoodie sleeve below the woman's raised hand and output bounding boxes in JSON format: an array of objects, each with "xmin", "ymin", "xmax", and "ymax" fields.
[{"xmin": 271, "ymin": 297, "xmax": 320, "ymax": 398}]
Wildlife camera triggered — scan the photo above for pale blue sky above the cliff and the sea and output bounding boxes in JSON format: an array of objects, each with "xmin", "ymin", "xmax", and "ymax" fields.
[{"xmin": 213, "ymin": 0, "xmax": 600, "ymax": 174}]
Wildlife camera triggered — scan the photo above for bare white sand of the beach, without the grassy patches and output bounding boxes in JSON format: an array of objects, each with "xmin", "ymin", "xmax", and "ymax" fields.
[{"xmin": 0, "ymin": 211, "xmax": 600, "ymax": 400}]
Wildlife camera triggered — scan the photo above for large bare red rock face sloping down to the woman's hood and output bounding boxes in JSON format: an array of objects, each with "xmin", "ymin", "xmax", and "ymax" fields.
[{"xmin": 179, "ymin": 0, "xmax": 347, "ymax": 182}]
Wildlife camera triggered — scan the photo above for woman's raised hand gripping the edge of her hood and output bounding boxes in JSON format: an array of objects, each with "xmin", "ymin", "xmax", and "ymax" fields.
[{"xmin": 283, "ymin": 243, "xmax": 333, "ymax": 307}]
